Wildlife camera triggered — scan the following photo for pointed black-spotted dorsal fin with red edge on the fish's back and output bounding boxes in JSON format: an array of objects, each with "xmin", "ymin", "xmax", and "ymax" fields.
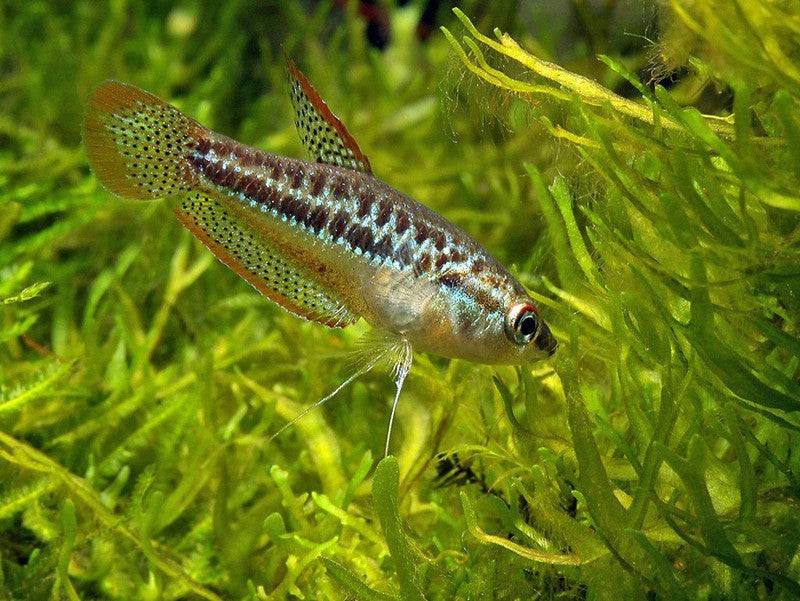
[{"xmin": 286, "ymin": 58, "xmax": 372, "ymax": 173}]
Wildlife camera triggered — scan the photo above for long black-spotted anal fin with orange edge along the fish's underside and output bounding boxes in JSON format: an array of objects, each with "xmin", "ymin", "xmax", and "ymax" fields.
[{"xmin": 175, "ymin": 192, "xmax": 358, "ymax": 328}]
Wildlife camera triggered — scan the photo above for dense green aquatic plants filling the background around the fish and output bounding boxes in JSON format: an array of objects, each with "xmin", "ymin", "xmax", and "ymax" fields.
[{"xmin": 0, "ymin": 0, "xmax": 800, "ymax": 600}]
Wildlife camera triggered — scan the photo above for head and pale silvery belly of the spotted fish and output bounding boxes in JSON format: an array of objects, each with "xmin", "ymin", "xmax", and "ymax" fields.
[{"xmin": 352, "ymin": 237, "xmax": 558, "ymax": 365}]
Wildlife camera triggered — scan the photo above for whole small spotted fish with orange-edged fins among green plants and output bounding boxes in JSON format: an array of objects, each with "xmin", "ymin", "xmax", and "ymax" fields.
[{"xmin": 84, "ymin": 60, "xmax": 557, "ymax": 453}]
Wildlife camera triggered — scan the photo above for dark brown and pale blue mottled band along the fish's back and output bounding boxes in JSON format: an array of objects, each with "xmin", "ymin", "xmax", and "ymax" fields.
[{"xmin": 190, "ymin": 131, "xmax": 524, "ymax": 306}]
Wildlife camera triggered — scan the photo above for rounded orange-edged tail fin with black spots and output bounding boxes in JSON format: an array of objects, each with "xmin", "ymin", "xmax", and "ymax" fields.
[{"xmin": 84, "ymin": 81, "xmax": 206, "ymax": 200}]
